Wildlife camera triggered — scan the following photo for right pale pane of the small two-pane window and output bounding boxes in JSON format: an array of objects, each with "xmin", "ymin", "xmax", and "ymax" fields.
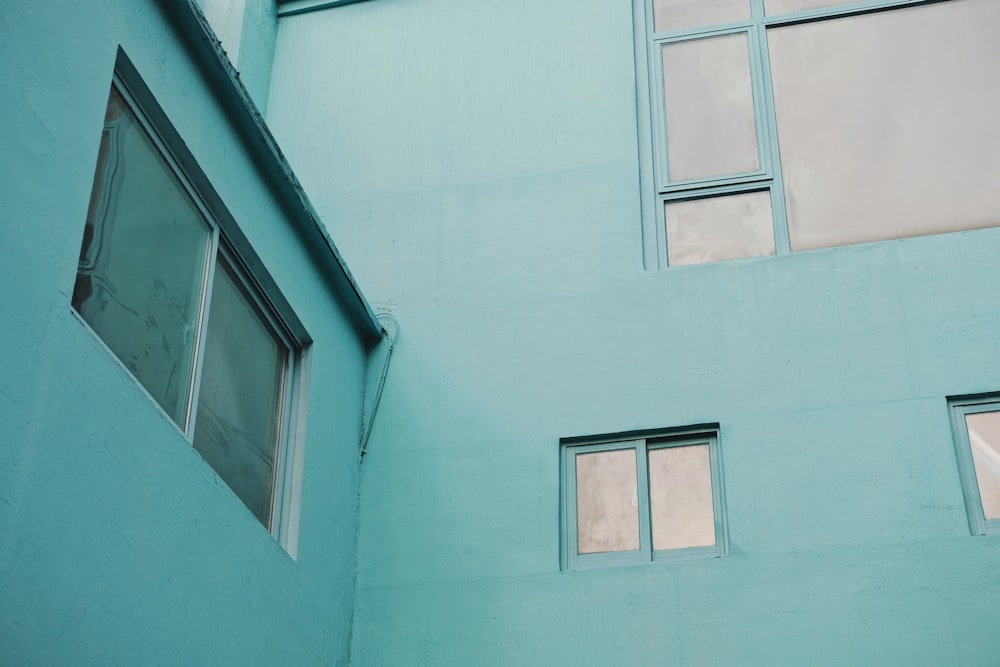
[{"xmin": 649, "ymin": 445, "xmax": 715, "ymax": 551}]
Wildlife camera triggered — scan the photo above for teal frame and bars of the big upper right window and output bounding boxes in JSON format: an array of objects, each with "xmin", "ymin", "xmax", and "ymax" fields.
[{"xmin": 632, "ymin": 0, "xmax": 968, "ymax": 269}]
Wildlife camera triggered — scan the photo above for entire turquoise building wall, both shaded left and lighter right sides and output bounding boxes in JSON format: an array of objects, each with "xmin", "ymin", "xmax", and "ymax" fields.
[{"xmin": 0, "ymin": 0, "xmax": 1000, "ymax": 666}]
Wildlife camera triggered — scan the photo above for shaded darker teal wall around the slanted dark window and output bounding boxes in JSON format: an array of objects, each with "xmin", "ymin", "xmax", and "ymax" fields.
[{"xmin": 0, "ymin": 0, "xmax": 365, "ymax": 666}]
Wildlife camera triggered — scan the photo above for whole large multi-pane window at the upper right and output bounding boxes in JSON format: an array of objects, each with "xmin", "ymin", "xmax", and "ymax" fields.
[{"xmin": 635, "ymin": 0, "xmax": 1000, "ymax": 267}]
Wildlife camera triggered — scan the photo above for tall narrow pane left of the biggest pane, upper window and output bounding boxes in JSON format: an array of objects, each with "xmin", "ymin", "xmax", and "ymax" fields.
[{"xmin": 663, "ymin": 34, "xmax": 760, "ymax": 181}]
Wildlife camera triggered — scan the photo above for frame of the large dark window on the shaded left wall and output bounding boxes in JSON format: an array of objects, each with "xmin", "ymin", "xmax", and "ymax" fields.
[{"xmin": 70, "ymin": 56, "xmax": 313, "ymax": 557}]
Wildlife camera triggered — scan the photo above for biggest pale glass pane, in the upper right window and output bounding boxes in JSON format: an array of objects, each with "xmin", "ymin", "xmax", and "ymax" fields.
[{"xmin": 768, "ymin": 0, "xmax": 1000, "ymax": 250}]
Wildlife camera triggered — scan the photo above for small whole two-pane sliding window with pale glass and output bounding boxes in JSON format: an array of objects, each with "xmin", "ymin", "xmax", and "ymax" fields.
[{"xmin": 562, "ymin": 427, "xmax": 728, "ymax": 569}]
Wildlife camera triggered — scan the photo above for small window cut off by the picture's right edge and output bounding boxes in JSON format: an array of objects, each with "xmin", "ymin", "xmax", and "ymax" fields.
[{"xmin": 949, "ymin": 395, "xmax": 1000, "ymax": 535}]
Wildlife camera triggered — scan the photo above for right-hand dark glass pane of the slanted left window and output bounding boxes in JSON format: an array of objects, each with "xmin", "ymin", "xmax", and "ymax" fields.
[{"xmin": 194, "ymin": 262, "xmax": 288, "ymax": 526}]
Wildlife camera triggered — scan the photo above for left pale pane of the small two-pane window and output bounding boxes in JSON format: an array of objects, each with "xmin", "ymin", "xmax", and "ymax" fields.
[{"xmin": 576, "ymin": 449, "xmax": 639, "ymax": 554}]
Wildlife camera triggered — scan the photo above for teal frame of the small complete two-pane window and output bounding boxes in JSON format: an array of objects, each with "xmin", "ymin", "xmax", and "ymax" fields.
[{"xmin": 560, "ymin": 424, "xmax": 729, "ymax": 571}]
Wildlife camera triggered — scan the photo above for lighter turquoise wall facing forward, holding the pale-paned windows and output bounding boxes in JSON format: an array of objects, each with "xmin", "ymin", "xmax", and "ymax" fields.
[{"xmin": 269, "ymin": 0, "xmax": 1000, "ymax": 666}]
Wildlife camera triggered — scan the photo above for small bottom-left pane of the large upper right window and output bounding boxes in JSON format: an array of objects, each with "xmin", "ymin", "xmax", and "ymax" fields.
[{"xmin": 665, "ymin": 192, "xmax": 774, "ymax": 266}]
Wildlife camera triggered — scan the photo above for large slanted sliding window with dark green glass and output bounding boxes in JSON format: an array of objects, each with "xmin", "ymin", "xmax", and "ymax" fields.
[{"xmin": 72, "ymin": 76, "xmax": 309, "ymax": 543}]
